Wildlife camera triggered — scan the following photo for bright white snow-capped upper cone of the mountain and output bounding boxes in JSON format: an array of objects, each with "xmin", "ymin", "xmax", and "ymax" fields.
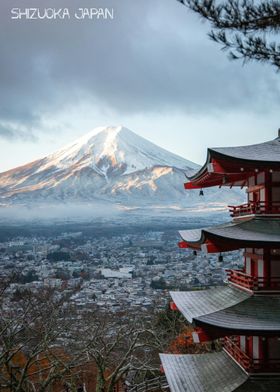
[{"xmin": 40, "ymin": 126, "xmax": 197, "ymax": 176}]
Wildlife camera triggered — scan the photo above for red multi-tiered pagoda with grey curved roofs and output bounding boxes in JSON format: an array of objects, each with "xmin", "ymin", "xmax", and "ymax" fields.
[{"xmin": 160, "ymin": 131, "xmax": 280, "ymax": 392}]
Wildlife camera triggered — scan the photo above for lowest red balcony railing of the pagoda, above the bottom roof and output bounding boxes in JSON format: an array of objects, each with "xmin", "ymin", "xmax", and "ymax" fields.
[{"xmin": 224, "ymin": 336, "xmax": 280, "ymax": 373}]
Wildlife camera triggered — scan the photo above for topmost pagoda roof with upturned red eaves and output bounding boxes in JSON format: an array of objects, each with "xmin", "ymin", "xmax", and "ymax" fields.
[{"xmin": 185, "ymin": 137, "xmax": 280, "ymax": 189}]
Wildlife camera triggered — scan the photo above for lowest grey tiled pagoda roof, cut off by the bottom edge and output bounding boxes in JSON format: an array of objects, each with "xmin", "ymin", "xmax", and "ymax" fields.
[{"xmin": 160, "ymin": 351, "xmax": 280, "ymax": 392}]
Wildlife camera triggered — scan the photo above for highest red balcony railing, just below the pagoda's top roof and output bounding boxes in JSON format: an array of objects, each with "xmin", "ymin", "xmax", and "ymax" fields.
[{"xmin": 228, "ymin": 201, "xmax": 280, "ymax": 218}]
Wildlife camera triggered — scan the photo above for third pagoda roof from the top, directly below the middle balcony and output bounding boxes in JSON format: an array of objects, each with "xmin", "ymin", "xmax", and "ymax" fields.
[{"xmin": 170, "ymin": 286, "xmax": 280, "ymax": 333}]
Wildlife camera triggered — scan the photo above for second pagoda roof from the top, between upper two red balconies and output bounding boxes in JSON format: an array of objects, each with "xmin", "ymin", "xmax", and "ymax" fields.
[{"xmin": 179, "ymin": 218, "xmax": 280, "ymax": 252}]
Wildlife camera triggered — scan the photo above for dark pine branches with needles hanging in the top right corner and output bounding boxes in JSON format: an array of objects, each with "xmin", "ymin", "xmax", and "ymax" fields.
[{"xmin": 177, "ymin": 0, "xmax": 280, "ymax": 70}]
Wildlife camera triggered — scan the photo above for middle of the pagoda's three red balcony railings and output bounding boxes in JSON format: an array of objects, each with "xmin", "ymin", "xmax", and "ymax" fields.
[{"xmin": 226, "ymin": 269, "xmax": 280, "ymax": 291}]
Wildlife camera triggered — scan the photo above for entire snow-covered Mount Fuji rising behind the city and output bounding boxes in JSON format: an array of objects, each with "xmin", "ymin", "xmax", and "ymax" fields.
[{"xmin": 0, "ymin": 126, "xmax": 242, "ymax": 207}]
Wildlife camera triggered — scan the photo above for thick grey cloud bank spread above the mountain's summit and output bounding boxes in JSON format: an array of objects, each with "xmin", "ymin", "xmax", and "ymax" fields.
[{"xmin": 0, "ymin": 0, "xmax": 280, "ymax": 138}]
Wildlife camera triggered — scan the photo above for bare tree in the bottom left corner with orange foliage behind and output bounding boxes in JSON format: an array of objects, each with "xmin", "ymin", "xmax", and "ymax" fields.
[{"xmin": 0, "ymin": 287, "xmax": 82, "ymax": 392}]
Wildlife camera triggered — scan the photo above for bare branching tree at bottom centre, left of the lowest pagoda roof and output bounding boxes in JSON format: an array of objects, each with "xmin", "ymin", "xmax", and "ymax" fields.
[{"xmin": 71, "ymin": 311, "xmax": 157, "ymax": 392}]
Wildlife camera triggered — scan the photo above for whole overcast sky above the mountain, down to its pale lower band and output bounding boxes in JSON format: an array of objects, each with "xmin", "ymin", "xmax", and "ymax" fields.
[{"xmin": 0, "ymin": 0, "xmax": 280, "ymax": 171}]
